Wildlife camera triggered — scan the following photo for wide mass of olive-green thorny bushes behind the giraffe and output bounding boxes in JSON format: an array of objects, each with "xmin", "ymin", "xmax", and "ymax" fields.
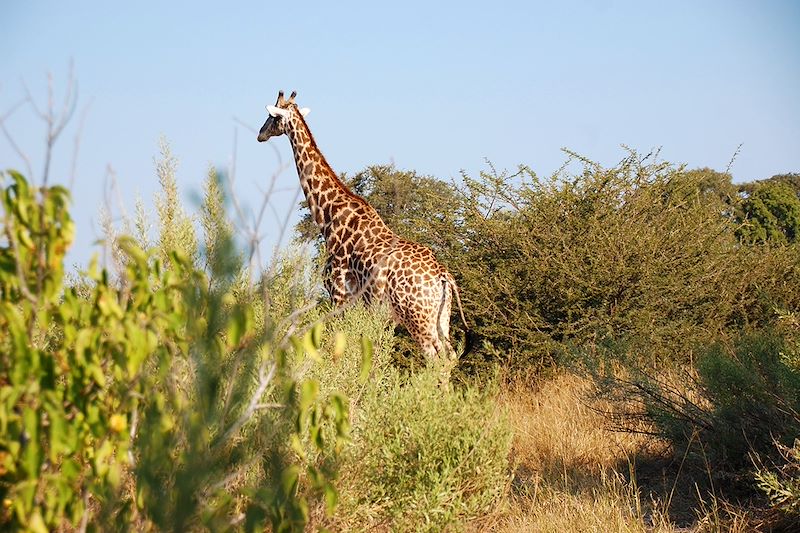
[{"xmin": 322, "ymin": 159, "xmax": 800, "ymax": 374}]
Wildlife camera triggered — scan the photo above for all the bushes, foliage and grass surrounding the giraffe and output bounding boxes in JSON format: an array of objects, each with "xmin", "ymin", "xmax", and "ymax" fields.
[{"xmin": 0, "ymin": 115, "xmax": 800, "ymax": 532}]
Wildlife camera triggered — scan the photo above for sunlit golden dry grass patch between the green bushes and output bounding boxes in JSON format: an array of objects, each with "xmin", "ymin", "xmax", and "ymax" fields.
[{"xmin": 488, "ymin": 375, "xmax": 674, "ymax": 532}]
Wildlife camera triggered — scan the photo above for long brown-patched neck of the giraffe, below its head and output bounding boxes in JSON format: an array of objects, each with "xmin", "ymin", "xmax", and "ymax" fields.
[{"xmin": 286, "ymin": 115, "xmax": 366, "ymax": 232}]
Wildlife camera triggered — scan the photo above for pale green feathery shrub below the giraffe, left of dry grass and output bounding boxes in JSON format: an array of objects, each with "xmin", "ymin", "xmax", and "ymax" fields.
[{"xmin": 222, "ymin": 247, "xmax": 510, "ymax": 530}]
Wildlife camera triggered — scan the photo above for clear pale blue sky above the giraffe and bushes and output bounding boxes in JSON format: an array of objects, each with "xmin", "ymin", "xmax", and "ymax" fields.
[{"xmin": 0, "ymin": 0, "xmax": 800, "ymax": 263}]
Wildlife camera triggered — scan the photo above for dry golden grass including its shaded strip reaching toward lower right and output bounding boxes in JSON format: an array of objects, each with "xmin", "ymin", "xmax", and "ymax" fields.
[{"xmin": 488, "ymin": 374, "xmax": 761, "ymax": 533}]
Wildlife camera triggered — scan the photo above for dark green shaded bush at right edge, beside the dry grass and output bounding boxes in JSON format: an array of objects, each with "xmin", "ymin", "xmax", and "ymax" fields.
[{"xmin": 584, "ymin": 331, "xmax": 800, "ymax": 492}]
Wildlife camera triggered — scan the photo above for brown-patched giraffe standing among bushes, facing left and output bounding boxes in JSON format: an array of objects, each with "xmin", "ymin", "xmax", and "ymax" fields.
[{"xmin": 258, "ymin": 91, "xmax": 467, "ymax": 361}]
